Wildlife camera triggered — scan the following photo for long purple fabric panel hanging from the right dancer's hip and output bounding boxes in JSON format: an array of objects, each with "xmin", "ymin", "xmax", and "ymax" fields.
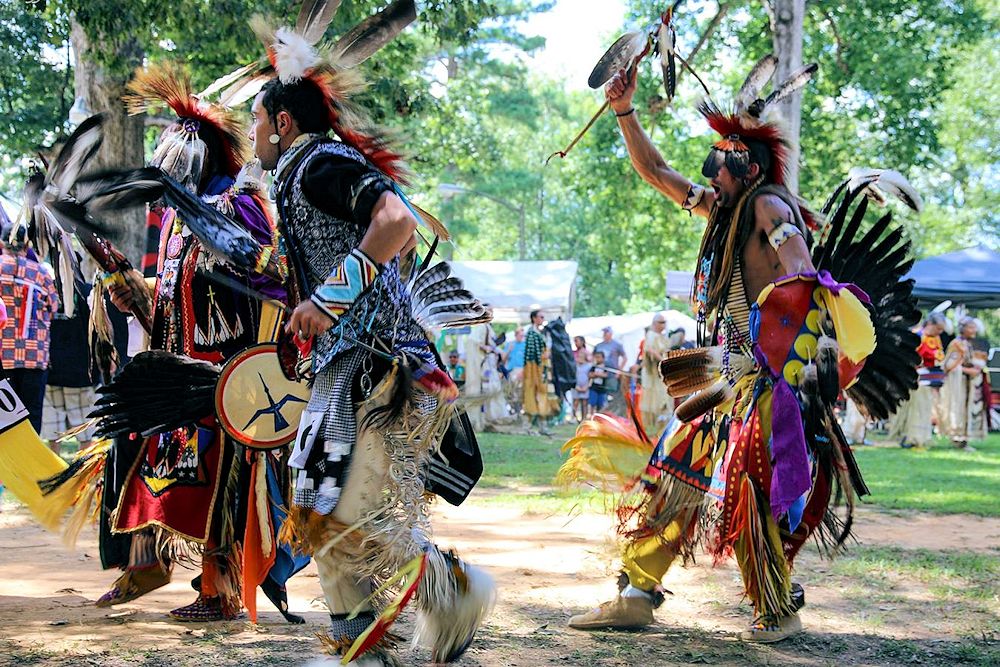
[{"xmin": 771, "ymin": 378, "xmax": 812, "ymax": 520}]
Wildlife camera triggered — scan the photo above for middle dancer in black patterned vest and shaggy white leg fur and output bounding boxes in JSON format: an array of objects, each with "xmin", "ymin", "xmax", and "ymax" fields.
[{"xmin": 168, "ymin": 2, "xmax": 494, "ymax": 664}]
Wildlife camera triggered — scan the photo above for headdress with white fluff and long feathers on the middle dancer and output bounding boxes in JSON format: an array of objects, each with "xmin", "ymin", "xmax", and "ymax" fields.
[{"xmin": 206, "ymin": 0, "xmax": 417, "ymax": 182}]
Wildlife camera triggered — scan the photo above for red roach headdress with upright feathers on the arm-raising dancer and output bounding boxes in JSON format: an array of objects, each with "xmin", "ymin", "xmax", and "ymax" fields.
[{"xmin": 698, "ymin": 54, "xmax": 817, "ymax": 185}]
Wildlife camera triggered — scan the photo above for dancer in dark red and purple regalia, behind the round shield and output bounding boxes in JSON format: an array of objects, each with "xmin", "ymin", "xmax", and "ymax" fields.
[{"xmin": 36, "ymin": 64, "xmax": 308, "ymax": 622}]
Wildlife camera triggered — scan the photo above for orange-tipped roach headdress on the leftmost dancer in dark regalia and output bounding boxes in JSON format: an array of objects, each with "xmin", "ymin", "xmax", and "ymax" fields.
[{"xmin": 122, "ymin": 62, "xmax": 250, "ymax": 192}]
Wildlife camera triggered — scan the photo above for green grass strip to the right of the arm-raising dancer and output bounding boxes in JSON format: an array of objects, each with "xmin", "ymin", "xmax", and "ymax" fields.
[{"xmin": 854, "ymin": 433, "xmax": 1000, "ymax": 517}]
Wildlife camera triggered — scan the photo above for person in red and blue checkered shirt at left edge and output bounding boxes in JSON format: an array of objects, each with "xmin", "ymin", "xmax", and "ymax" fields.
[{"xmin": 0, "ymin": 222, "xmax": 59, "ymax": 432}]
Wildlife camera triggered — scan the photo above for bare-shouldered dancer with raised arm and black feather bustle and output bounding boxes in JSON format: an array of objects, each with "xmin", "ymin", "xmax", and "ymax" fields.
[{"xmin": 560, "ymin": 56, "xmax": 919, "ymax": 642}]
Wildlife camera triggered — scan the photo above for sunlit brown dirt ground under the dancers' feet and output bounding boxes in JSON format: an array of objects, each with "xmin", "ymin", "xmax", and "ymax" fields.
[{"xmin": 0, "ymin": 503, "xmax": 1000, "ymax": 667}]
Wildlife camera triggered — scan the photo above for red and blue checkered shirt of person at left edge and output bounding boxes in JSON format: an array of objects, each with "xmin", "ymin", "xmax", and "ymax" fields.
[{"xmin": 0, "ymin": 250, "xmax": 59, "ymax": 369}]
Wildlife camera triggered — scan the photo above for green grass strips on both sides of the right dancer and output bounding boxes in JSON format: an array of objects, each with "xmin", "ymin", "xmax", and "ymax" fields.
[{"xmin": 473, "ymin": 426, "xmax": 1000, "ymax": 517}]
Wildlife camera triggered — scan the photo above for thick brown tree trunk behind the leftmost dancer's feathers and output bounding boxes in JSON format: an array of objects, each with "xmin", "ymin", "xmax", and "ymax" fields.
[{"xmin": 70, "ymin": 21, "xmax": 146, "ymax": 268}]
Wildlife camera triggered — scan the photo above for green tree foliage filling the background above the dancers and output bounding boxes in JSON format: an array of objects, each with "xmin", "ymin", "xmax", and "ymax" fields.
[{"xmin": 0, "ymin": 0, "xmax": 1000, "ymax": 315}]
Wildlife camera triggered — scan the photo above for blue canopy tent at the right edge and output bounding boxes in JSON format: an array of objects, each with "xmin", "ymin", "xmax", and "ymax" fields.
[{"xmin": 907, "ymin": 246, "xmax": 1000, "ymax": 309}]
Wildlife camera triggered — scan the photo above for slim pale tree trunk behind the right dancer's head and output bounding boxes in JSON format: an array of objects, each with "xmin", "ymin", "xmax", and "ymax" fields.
[{"xmin": 770, "ymin": 0, "xmax": 806, "ymax": 193}]
